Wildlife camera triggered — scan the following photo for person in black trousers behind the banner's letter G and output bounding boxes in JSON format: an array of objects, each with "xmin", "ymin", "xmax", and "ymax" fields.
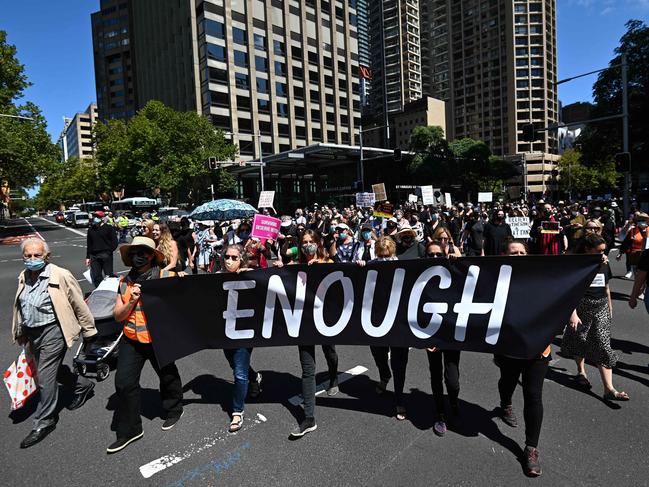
[{"xmin": 426, "ymin": 240, "xmax": 460, "ymax": 436}]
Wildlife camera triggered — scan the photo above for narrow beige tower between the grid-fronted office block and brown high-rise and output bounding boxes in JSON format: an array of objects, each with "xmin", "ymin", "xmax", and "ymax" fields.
[{"xmin": 370, "ymin": 0, "xmax": 422, "ymax": 146}]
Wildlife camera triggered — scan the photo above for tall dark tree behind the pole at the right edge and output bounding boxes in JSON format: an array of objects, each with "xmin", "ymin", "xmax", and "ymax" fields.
[{"xmin": 578, "ymin": 20, "xmax": 649, "ymax": 170}]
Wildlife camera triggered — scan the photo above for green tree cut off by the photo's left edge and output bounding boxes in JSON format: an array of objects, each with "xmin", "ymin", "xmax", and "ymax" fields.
[{"xmin": 0, "ymin": 30, "xmax": 59, "ymax": 188}]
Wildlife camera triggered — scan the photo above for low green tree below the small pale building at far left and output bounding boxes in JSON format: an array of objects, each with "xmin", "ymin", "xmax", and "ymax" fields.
[{"xmin": 36, "ymin": 157, "xmax": 101, "ymax": 210}]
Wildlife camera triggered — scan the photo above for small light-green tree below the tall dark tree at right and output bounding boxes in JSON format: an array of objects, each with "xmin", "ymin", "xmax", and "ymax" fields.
[{"xmin": 559, "ymin": 149, "xmax": 617, "ymax": 195}]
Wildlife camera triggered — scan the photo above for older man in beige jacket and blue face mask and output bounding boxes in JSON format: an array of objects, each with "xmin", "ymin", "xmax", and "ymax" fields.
[{"xmin": 12, "ymin": 238, "xmax": 97, "ymax": 448}]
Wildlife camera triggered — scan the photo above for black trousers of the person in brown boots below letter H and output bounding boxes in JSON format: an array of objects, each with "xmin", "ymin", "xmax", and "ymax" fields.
[{"xmin": 496, "ymin": 355, "xmax": 549, "ymax": 448}]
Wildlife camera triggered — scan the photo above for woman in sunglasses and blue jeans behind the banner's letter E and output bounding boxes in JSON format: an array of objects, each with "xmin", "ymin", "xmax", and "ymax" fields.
[{"xmin": 221, "ymin": 244, "xmax": 261, "ymax": 433}]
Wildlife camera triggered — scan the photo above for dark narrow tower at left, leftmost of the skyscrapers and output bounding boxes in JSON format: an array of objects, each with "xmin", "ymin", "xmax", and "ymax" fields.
[{"xmin": 91, "ymin": 0, "xmax": 137, "ymax": 121}]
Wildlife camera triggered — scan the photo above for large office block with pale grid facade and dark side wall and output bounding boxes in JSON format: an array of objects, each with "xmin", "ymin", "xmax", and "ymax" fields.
[{"xmin": 95, "ymin": 0, "xmax": 360, "ymax": 162}]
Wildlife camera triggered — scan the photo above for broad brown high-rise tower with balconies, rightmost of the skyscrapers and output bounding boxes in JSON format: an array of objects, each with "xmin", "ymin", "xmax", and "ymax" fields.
[{"xmin": 421, "ymin": 0, "xmax": 558, "ymax": 160}]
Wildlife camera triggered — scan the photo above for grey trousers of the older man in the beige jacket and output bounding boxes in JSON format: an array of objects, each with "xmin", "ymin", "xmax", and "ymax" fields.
[{"xmin": 23, "ymin": 323, "xmax": 92, "ymax": 429}]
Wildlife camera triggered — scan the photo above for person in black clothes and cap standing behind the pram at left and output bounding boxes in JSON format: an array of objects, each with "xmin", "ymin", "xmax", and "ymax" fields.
[{"xmin": 86, "ymin": 211, "xmax": 117, "ymax": 287}]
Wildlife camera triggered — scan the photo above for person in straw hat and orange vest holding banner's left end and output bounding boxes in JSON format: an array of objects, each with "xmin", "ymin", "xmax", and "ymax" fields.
[{"xmin": 106, "ymin": 237, "xmax": 183, "ymax": 454}]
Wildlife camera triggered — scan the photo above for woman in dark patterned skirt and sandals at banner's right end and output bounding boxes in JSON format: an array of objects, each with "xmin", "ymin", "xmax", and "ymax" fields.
[{"xmin": 561, "ymin": 234, "xmax": 629, "ymax": 401}]
